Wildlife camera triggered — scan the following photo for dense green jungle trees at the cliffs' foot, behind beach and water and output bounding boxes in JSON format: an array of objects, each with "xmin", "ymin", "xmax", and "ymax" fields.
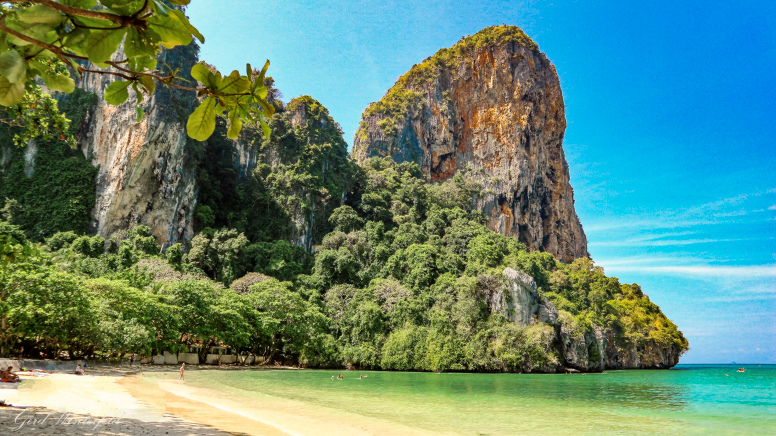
[{"xmin": 0, "ymin": 155, "xmax": 687, "ymax": 371}]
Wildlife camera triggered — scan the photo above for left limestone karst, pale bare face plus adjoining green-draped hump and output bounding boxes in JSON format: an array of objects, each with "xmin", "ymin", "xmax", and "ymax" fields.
[{"xmin": 52, "ymin": 44, "xmax": 350, "ymax": 251}]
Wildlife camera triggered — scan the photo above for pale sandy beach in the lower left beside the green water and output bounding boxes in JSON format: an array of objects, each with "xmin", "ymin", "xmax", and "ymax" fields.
[{"xmin": 0, "ymin": 366, "xmax": 436, "ymax": 436}]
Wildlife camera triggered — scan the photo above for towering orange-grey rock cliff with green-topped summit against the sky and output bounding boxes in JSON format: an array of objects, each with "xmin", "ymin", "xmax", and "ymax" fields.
[{"xmin": 352, "ymin": 26, "xmax": 587, "ymax": 262}]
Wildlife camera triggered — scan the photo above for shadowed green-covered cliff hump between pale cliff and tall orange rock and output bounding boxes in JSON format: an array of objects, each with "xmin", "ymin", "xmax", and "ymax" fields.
[{"xmin": 191, "ymin": 92, "xmax": 354, "ymax": 250}]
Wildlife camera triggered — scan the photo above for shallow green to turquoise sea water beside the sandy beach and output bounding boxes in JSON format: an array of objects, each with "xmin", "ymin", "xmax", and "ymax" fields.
[{"xmin": 155, "ymin": 365, "xmax": 776, "ymax": 435}]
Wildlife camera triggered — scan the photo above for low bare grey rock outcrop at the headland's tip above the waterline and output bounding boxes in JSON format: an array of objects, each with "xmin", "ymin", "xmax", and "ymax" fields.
[{"xmin": 498, "ymin": 268, "xmax": 681, "ymax": 372}]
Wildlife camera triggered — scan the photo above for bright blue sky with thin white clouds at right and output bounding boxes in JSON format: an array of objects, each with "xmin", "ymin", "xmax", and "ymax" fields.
[{"xmin": 189, "ymin": 0, "xmax": 776, "ymax": 363}]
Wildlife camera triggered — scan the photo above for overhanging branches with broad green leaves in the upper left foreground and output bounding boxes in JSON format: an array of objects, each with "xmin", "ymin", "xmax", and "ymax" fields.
[{"xmin": 0, "ymin": 0, "xmax": 274, "ymax": 143}]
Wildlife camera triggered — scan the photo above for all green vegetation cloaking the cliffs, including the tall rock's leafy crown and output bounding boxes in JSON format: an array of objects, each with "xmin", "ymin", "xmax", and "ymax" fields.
[{"xmin": 0, "ymin": 23, "xmax": 688, "ymax": 372}]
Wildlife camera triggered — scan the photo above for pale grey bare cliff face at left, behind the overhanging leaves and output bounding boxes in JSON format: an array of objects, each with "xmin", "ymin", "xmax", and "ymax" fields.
[{"xmin": 73, "ymin": 46, "xmax": 197, "ymax": 249}]
